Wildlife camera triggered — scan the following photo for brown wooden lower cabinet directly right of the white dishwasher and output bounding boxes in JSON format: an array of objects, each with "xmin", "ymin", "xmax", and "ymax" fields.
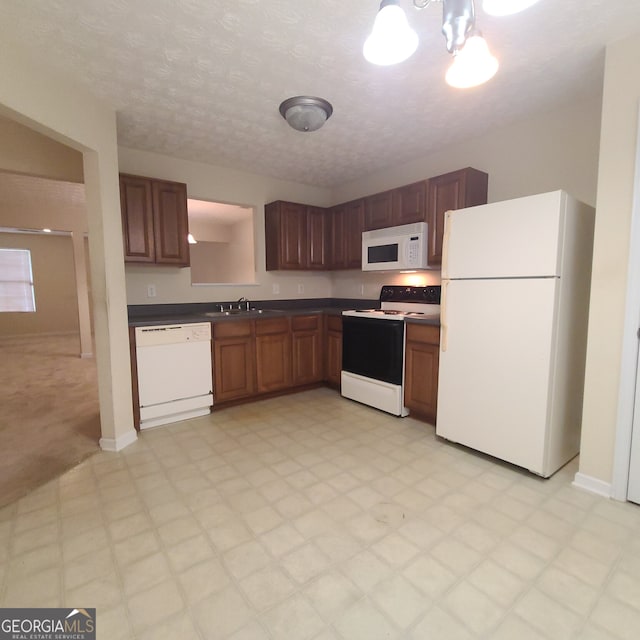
[{"xmin": 213, "ymin": 320, "xmax": 255, "ymax": 406}]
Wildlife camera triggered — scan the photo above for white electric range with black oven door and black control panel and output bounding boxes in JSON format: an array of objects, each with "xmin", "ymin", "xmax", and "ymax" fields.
[{"xmin": 341, "ymin": 285, "xmax": 441, "ymax": 417}]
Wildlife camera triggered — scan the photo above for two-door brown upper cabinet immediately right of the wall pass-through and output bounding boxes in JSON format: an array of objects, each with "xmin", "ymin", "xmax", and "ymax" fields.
[{"xmin": 264, "ymin": 200, "xmax": 330, "ymax": 271}]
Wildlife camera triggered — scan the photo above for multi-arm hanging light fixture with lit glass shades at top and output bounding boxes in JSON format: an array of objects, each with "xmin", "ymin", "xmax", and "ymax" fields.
[{"xmin": 362, "ymin": 0, "xmax": 539, "ymax": 89}]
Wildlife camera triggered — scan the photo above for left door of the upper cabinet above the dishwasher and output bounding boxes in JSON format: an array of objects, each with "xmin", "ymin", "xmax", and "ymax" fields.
[{"xmin": 120, "ymin": 175, "xmax": 155, "ymax": 262}]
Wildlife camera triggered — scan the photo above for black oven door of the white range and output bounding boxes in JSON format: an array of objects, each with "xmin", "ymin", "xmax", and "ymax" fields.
[{"xmin": 342, "ymin": 316, "xmax": 404, "ymax": 385}]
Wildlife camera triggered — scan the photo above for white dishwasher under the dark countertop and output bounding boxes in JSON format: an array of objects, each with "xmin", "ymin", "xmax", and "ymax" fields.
[{"xmin": 135, "ymin": 322, "xmax": 213, "ymax": 429}]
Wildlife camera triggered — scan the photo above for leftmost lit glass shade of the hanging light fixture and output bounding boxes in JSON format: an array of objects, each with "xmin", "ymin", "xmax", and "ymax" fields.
[{"xmin": 362, "ymin": 0, "xmax": 418, "ymax": 66}]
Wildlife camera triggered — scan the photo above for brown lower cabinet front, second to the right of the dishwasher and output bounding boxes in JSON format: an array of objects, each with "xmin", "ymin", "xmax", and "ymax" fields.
[{"xmin": 256, "ymin": 318, "xmax": 291, "ymax": 393}]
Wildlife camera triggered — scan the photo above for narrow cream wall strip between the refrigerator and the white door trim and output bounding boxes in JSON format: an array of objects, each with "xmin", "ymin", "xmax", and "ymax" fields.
[{"xmin": 580, "ymin": 35, "xmax": 640, "ymax": 490}]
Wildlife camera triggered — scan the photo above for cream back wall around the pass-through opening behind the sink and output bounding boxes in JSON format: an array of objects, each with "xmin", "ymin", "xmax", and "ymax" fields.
[{"xmin": 118, "ymin": 147, "xmax": 331, "ymax": 304}]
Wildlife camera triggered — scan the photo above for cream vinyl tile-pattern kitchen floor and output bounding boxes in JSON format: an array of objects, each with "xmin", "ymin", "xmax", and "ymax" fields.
[{"xmin": 0, "ymin": 389, "xmax": 640, "ymax": 640}]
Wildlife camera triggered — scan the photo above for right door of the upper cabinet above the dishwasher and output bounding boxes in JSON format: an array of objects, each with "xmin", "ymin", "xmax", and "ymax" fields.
[{"xmin": 151, "ymin": 180, "xmax": 189, "ymax": 266}]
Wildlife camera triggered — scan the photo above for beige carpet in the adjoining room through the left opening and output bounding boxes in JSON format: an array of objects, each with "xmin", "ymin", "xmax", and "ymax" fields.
[{"xmin": 0, "ymin": 335, "xmax": 100, "ymax": 507}]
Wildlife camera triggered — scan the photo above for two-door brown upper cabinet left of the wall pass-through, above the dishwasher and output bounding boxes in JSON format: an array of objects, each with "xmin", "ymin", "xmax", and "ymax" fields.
[{"xmin": 120, "ymin": 174, "xmax": 189, "ymax": 267}]
